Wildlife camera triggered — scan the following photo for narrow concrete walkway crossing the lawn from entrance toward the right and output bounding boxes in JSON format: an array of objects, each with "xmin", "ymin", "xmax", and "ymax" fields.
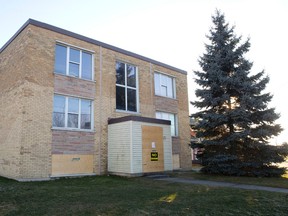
[{"xmin": 154, "ymin": 176, "xmax": 288, "ymax": 193}]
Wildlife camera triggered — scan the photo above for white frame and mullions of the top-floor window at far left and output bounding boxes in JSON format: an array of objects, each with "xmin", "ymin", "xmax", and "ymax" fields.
[{"xmin": 54, "ymin": 42, "xmax": 94, "ymax": 81}]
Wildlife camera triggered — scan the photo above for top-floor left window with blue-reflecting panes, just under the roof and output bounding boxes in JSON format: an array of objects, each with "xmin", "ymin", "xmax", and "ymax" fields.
[{"xmin": 54, "ymin": 44, "xmax": 93, "ymax": 80}]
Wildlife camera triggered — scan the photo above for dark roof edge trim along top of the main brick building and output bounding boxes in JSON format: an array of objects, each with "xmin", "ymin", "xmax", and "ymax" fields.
[{"xmin": 0, "ymin": 19, "xmax": 187, "ymax": 75}]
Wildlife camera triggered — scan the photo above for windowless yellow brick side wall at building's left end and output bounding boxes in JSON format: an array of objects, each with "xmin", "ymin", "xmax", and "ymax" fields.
[{"xmin": 0, "ymin": 27, "xmax": 29, "ymax": 178}]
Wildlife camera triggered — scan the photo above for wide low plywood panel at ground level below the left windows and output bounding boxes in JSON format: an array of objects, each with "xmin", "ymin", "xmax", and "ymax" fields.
[{"xmin": 52, "ymin": 154, "xmax": 93, "ymax": 175}]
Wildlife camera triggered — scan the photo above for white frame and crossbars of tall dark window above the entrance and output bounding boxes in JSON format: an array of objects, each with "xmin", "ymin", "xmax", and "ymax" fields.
[{"xmin": 115, "ymin": 60, "xmax": 140, "ymax": 113}]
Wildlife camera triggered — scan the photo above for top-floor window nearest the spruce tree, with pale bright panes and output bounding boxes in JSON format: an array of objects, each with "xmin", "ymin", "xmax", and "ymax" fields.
[{"xmin": 154, "ymin": 72, "xmax": 176, "ymax": 98}]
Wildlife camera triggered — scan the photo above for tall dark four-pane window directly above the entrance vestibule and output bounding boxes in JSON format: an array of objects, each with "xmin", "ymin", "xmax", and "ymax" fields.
[{"xmin": 116, "ymin": 62, "xmax": 138, "ymax": 112}]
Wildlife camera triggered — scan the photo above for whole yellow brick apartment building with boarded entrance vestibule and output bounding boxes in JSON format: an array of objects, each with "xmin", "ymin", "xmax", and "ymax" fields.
[{"xmin": 0, "ymin": 19, "xmax": 191, "ymax": 181}]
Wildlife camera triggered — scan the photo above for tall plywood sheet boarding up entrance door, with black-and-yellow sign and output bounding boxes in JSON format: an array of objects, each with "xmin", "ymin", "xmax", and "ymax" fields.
[{"xmin": 142, "ymin": 125, "xmax": 164, "ymax": 173}]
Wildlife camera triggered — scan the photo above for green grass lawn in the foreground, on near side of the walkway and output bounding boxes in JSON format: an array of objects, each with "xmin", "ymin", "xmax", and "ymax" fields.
[{"xmin": 0, "ymin": 176, "xmax": 288, "ymax": 216}]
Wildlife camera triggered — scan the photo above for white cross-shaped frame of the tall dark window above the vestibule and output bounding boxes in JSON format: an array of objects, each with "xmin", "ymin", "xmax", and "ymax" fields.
[{"xmin": 115, "ymin": 61, "xmax": 139, "ymax": 113}]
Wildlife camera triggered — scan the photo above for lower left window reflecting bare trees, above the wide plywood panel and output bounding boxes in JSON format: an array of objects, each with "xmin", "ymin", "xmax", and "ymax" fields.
[{"xmin": 53, "ymin": 95, "xmax": 93, "ymax": 130}]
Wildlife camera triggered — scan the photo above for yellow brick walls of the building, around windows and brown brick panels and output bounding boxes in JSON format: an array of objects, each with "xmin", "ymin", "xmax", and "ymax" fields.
[{"xmin": 0, "ymin": 22, "xmax": 191, "ymax": 179}]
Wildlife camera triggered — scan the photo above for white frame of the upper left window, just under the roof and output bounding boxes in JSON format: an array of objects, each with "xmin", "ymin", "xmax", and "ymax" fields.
[{"xmin": 54, "ymin": 42, "xmax": 94, "ymax": 81}]
